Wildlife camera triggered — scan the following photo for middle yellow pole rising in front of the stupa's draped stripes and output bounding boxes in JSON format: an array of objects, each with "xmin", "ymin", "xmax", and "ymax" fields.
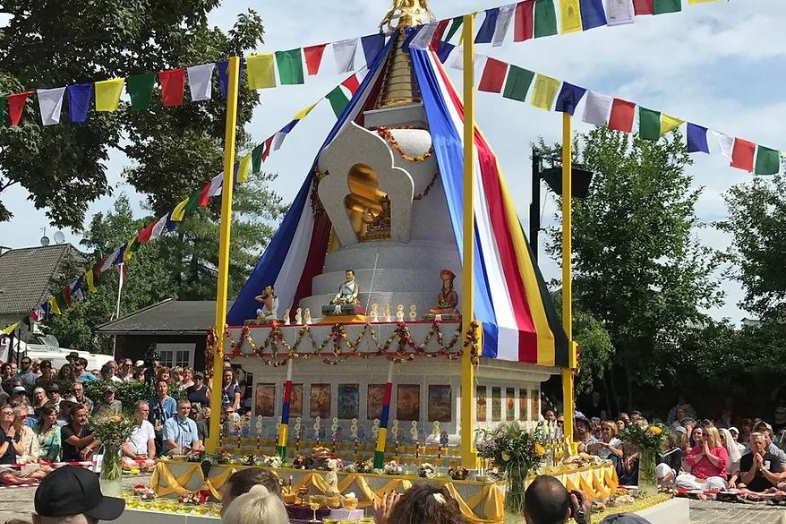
[{"xmin": 461, "ymin": 14, "xmax": 478, "ymax": 469}]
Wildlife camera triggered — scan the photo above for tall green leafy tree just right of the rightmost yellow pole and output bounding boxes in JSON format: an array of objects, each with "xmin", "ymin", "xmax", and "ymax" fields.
[{"xmin": 546, "ymin": 128, "xmax": 722, "ymax": 407}]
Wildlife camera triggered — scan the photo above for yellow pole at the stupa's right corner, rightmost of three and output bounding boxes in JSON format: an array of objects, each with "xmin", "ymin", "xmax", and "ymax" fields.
[{"xmin": 562, "ymin": 112, "xmax": 576, "ymax": 441}]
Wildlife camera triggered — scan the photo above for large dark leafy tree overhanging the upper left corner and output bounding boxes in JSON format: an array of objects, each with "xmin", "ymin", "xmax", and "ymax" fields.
[{"xmin": 0, "ymin": 0, "xmax": 263, "ymax": 229}]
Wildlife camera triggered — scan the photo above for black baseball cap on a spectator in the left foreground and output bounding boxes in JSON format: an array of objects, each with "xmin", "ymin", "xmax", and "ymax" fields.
[{"xmin": 35, "ymin": 466, "xmax": 126, "ymax": 520}]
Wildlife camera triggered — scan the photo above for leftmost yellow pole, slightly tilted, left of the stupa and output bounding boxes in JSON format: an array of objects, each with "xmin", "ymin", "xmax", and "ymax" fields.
[{"xmin": 205, "ymin": 56, "xmax": 240, "ymax": 453}]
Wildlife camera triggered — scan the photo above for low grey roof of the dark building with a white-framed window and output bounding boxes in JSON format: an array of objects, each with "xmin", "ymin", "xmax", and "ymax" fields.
[{"xmin": 96, "ymin": 299, "xmax": 231, "ymax": 335}]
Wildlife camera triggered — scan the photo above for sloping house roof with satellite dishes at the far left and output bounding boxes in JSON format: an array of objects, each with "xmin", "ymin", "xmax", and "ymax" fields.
[{"xmin": 0, "ymin": 244, "xmax": 84, "ymax": 314}]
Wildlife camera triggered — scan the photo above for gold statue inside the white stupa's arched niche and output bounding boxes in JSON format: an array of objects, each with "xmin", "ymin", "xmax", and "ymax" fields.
[{"xmin": 344, "ymin": 164, "xmax": 390, "ymax": 242}]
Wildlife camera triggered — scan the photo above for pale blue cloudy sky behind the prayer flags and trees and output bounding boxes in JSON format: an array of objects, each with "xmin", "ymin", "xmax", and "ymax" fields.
[{"xmin": 0, "ymin": 0, "xmax": 786, "ymax": 322}]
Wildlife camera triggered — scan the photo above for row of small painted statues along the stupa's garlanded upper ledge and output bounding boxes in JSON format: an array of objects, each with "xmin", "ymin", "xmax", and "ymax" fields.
[{"xmin": 255, "ymin": 269, "xmax": 458, "ymax": 325}]
